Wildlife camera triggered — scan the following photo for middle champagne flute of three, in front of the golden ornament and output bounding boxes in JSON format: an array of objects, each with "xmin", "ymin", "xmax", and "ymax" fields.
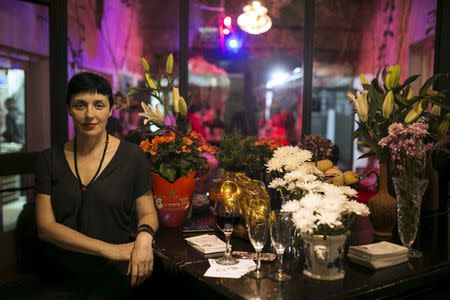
[{"xmin": 247, "ymin": 198, "xmax": 269, "ymax": 279}]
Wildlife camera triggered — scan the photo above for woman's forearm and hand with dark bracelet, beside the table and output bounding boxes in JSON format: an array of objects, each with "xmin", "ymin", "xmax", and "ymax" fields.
[{"xmin": 128, "ymin": 191, "xmax": 158, "ymax": 286}]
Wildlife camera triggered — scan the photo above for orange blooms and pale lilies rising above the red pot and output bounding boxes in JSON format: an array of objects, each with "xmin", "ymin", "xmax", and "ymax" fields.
[{"xmin": 127, "ymin": 54, "xmax": 217, "ymax": 182}]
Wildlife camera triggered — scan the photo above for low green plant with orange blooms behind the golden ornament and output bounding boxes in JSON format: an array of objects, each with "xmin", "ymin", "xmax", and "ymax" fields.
[{"xmin": 216, "ymin": 132, "xmax": 281, "ymax": 183}]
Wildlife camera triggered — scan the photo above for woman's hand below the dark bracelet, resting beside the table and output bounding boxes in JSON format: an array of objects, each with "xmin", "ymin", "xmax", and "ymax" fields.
[{"xmin": 127, "ymin": 232, "xmax": 153, "ymax": 287}]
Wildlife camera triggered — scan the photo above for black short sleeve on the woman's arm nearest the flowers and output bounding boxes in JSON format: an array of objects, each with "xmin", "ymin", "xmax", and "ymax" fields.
[{"xmin": 133, "ymin": 147, "xmax": 152, "ymax": 199}]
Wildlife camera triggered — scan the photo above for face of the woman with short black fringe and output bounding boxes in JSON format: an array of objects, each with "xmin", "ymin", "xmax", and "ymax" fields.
[{"xmin": 69, "ymin": 92, "xmax": 111, "ymax": 136}]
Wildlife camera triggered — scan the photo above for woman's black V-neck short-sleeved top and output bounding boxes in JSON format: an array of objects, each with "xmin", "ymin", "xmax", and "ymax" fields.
[{"xmin": 35, "ymin": 141, "xmax": 151, "ymax": 244}]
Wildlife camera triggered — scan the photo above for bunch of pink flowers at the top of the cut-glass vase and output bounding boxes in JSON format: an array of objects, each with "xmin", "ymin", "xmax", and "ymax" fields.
[{"xmin": 378, "ymin": 122, "xmax": 433, "ymax": 177}]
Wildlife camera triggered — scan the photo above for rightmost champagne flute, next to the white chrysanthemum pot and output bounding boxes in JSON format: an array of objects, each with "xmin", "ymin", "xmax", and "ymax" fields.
[{"xmin": 269, "ymin": 210, "xmax": 292, "ymax": 281}]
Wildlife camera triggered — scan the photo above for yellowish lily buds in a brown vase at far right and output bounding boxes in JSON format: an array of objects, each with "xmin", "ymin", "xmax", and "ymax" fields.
[{"xmin": 347, "ymin": 65, "xmax": 450, "ymax": 239}]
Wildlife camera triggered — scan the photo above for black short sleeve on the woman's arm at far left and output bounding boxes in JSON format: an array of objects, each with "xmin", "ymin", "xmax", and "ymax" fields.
[{"xmin": 34, "ymin": 150, "xmax": 52, "ymax": 195}]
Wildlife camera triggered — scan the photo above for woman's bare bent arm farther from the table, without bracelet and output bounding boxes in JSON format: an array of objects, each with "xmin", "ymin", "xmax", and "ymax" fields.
[{"xmin": 36, "ymin": 194, "xmax": 134, "ymax": 260}]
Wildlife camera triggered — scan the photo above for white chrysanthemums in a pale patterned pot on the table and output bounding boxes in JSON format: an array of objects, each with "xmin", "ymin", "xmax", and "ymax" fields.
[{"xmin": 267, "ymin": 146, "xmax": 369, "ymax": 280}]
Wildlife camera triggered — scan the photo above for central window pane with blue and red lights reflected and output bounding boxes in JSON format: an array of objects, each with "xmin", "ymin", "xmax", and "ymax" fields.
[{"xmin": 189, "ymin": 0, "xmax": 304, "ymax": 144}]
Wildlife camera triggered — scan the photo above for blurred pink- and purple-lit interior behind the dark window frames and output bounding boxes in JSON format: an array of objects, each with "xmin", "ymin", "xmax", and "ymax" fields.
[{"xmin": 0, "ymin": 0, "xmax": 442, "ymax": 241}]
